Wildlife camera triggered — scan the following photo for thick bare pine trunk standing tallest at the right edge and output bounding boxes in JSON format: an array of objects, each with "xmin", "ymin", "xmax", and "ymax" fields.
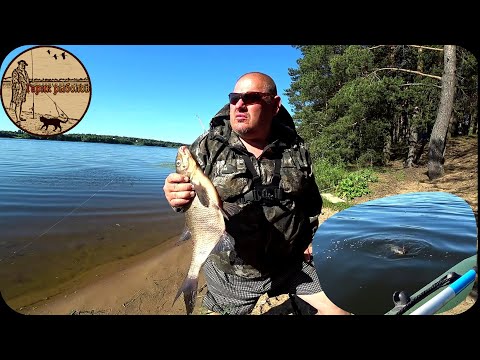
[{"xmin": 427, "ymin": 45, "xmax": 457, "ymax": 180}]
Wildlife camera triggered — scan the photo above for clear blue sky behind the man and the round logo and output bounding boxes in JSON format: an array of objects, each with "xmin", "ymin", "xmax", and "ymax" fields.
[{"xmin": 0, "ymin": 44, "xmax": 301, "ymax": 144}]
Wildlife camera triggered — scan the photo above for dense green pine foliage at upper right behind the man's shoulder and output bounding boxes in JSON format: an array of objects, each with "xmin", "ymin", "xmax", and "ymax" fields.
[{"xmin": 285, "ymin": 45, "xmax": 478, "ymax": 167}]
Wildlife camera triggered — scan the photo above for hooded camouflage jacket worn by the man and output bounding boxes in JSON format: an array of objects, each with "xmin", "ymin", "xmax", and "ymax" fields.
[{"xmin": 189, "ymin": 105, "xmax": 322, "ymax": 277}]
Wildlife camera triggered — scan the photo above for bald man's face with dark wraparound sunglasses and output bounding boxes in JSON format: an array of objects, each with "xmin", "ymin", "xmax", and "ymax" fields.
[{"xmin": 230, "ymin": 77, "xmax": 280, "ymax": 140}]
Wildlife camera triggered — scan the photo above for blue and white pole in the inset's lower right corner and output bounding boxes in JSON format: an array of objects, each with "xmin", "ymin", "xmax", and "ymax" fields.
[{"xmin": 410, "ymin": 266, "xmax": 477, "ymax": 315}]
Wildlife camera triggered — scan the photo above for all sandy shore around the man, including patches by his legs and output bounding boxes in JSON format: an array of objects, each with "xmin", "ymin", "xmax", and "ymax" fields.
[{"xmin": 9, "ymin": 209, "xmax": 334, "ymax": 315}]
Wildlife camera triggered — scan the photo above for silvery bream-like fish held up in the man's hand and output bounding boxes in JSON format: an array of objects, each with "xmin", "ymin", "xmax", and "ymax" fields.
[{"xmin": 173, "ymin": 146, "xmax": 238, "ymax": 315}]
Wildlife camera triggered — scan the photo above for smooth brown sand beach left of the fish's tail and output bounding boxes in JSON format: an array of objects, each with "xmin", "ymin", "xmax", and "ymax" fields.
[{"xmin": 9, "ymin": 233, "xmax": 203, "ymax": 315}]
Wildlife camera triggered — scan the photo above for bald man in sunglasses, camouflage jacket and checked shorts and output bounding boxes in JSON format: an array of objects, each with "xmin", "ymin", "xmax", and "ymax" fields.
[{"xmin": 163, "ymin": 72, "xmax": 348, "ymax": 314}]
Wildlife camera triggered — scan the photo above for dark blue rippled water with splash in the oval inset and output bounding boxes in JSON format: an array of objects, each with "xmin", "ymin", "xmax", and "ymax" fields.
[{"xmin": 313, "ymin": 192, "xmax": 477, "ymax": 314}]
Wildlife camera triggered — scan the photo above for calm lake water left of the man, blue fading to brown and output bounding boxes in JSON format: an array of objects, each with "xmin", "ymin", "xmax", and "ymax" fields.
[{"xmin": 0, "ymin": 138, "xmax": 183, "ymax": 310}]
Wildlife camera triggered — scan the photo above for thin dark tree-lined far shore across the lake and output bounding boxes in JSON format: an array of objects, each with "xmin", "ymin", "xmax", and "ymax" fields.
[{"xmin": 0, "ymin": 130, "xmax": 188, "ymax": 148}]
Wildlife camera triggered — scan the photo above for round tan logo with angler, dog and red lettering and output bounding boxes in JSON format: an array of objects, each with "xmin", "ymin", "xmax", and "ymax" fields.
[{"xmin": 0, "ymin": 46, "xmax": 92, "ymax": 137}]
